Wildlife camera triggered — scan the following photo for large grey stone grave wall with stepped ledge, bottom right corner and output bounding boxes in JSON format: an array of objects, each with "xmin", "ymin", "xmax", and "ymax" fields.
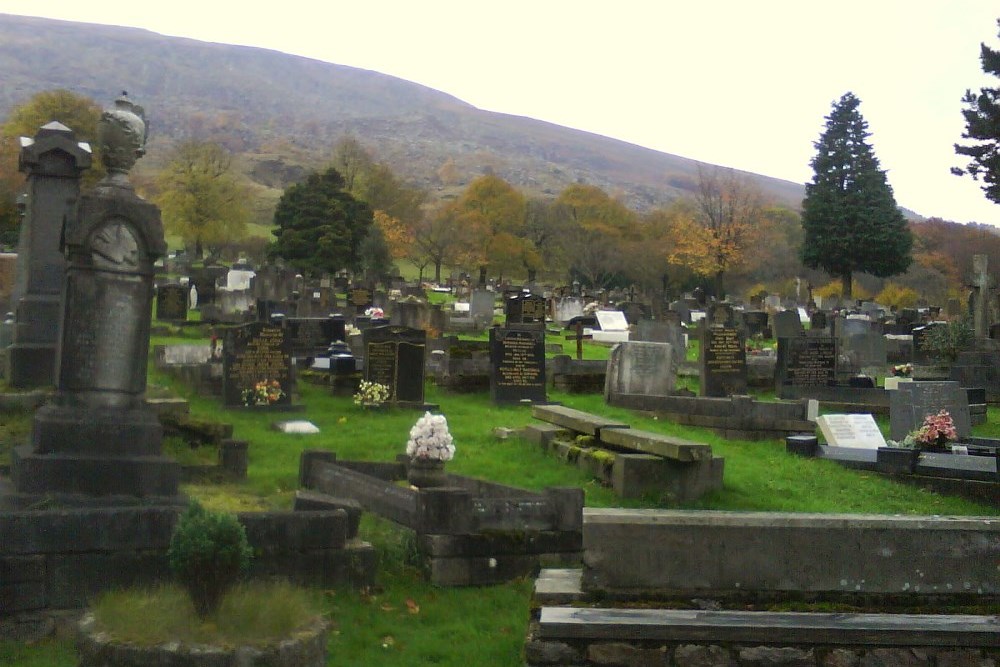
[{"xmin": 524, "ymin": 508, "xmax": 1000, "ymax": 667}]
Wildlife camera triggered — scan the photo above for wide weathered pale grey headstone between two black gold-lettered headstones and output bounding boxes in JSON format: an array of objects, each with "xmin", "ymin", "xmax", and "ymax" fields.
[{"xmin": 604, "ymin": 341, "xmax": 677, "ymax": 403}]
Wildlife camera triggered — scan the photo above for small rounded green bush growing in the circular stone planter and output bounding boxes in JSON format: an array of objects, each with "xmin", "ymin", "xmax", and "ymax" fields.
[{"xmin": 167, "ymin": 501, "xmax": 252, "ymax": 618}]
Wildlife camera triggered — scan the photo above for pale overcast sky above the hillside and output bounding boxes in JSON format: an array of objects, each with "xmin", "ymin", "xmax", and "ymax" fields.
[{"xmin": 7, "ymin": 0, "xmax": 1000, "ymax": 226}]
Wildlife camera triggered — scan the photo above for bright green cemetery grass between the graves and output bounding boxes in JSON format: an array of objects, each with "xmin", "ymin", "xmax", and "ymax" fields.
[{"xmin": 7, "ymin": 366, "xmax": 1000, "ymax": 667}]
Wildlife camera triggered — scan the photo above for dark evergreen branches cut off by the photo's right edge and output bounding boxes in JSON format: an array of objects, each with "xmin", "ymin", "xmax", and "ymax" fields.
[{"xmin": 951, "ymin": 21, "xmax": 1000, "ymax": 204}]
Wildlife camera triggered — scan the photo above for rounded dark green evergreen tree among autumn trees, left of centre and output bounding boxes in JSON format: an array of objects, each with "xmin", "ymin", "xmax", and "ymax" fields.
[{"xmin": 269, "ymin": 167, "xmax": 373, "ymax": 276}]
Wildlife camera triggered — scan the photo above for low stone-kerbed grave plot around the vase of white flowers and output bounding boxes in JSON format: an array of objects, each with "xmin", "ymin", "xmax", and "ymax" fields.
[{"xmin": 299, "ymin": 451, "xmax": 583, "ymax": 586}]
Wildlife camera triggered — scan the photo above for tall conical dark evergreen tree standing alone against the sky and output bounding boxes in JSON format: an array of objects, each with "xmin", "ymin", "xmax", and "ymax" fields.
[{"xmin": 800, "ymin": 93, "xmax": 913, "ymax": 298}]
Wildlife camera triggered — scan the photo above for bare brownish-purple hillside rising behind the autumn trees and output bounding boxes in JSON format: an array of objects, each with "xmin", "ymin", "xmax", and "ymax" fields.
[{"xmin": 0, "ymin": 14, "xmax": 803, "ymax": 210}]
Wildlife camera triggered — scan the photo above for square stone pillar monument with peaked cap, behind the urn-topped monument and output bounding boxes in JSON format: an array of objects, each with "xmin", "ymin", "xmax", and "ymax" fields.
[{"xmin": 8, "ymin": 122, "xmax": 91, "ymax": 389}]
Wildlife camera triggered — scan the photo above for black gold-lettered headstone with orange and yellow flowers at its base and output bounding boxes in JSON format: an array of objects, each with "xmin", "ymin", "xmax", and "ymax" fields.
[{"xmin": 222, "ymin": 322, "xmax": 292, "ymax": 409}]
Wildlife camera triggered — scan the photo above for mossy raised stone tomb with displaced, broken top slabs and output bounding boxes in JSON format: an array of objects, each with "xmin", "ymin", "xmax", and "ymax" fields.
[{"xmin": 524, "ymin": 405, "xmax": 724, "ymax": 502}]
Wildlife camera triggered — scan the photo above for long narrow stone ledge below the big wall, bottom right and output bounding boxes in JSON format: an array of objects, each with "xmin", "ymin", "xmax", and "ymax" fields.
[{"xmin": 536, "ymin": 607, "xmax": 1000, "ymax": 648}]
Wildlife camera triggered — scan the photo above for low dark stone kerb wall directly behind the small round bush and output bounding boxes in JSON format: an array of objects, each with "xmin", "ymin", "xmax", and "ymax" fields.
[{"xmin": 0, "ymin": 505, "xmax": 376, "ymax": 635}]
